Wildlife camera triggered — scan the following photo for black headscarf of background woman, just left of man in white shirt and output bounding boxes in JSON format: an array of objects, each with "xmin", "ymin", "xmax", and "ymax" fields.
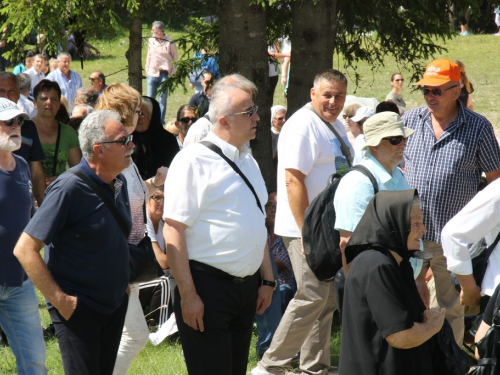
[{"xmin": 132, "ymin": 96, "xmax": 179, "ymax": 179}]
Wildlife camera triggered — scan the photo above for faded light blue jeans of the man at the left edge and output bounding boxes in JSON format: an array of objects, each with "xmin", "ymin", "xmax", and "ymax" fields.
[{"xmin": 0, "ymin": 280, "xmax": 47, "ymax": 375}]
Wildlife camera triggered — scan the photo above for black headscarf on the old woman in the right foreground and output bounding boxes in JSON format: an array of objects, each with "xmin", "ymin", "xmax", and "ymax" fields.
[{"xmin": 345, "ymin": 189, "xmax": 418, "ymax": 263}]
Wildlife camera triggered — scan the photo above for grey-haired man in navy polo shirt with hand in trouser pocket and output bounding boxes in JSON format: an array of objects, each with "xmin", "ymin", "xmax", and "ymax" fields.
[{"xmin": 14, "ymin": 111, "xmax": 134, "ymax": 375}]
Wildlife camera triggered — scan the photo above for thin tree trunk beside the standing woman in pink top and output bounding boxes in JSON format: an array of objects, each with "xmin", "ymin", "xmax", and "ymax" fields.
[{"xmin": 125, "ymin": 10, "xmax": 142, "ymax": 95}]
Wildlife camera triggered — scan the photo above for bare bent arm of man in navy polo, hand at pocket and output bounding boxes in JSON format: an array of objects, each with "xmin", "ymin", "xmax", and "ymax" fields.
[{"xmin": 14, "ymin": 233, "xmax": 77, "ymax": 320}]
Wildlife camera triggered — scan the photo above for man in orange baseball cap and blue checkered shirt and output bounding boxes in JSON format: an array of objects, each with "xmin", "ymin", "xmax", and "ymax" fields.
[{"xmin": 403, "ymin": 59, "xmax": 500, "ymax": 346}]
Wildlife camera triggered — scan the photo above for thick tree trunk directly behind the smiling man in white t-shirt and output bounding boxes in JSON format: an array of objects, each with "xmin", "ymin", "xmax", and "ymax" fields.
[{"xmin": 287, "ymin": 0, "xmax": 337, "ymax": 118}]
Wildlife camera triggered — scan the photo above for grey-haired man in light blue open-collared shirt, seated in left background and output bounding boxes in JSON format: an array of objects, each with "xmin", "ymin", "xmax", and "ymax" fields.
[{"xmin": 47, "ymin": 52, "xmax": 83, "ymax": 113}]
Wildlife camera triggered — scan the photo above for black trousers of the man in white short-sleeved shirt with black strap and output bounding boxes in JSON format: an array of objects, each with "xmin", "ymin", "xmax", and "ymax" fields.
[{"xmin": 174, "ymin": 269, "xmax": 260, "ymax": 375}]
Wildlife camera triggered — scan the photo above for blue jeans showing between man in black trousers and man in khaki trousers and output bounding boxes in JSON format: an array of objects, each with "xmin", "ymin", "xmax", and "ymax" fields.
[{"xmin": 255, "ymin": 260, "xmax": 283, "ymax": 357}]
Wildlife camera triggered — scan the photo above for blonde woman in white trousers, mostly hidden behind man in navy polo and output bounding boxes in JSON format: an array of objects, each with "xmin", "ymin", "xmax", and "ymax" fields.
[{"xmin": 96, "ymin": 83, "xmax": 166, "ymax": 375}]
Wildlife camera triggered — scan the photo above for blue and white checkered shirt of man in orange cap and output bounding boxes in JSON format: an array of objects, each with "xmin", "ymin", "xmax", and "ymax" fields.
[{"xmin": 403, "ymin": 104, "xmax": 500, "ymax": 243}]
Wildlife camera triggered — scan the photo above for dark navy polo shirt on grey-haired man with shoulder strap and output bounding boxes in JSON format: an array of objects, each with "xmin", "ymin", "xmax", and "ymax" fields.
[{"xmin": 25, "ymin": 158, "xmax": 132, "ymax": 314}]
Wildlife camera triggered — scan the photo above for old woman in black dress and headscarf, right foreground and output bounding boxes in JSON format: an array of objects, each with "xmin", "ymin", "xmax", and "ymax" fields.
[{"xmin": 339, "ymin": 190, "xmax": 445, "ymax": 375}]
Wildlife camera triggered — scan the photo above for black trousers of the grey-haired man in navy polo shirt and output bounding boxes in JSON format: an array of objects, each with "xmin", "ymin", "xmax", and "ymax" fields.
[{"xmin": 49, "ymin": 295, "xmax": 128, "ymax": 375}]
